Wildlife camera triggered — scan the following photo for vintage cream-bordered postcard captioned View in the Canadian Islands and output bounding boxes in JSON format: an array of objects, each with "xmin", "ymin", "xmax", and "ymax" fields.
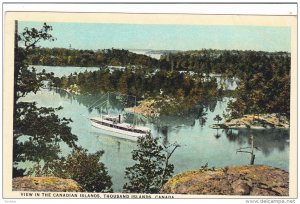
[{"xmin": 3, "ymin": 3, "xmax": 297, "ymax": 199}]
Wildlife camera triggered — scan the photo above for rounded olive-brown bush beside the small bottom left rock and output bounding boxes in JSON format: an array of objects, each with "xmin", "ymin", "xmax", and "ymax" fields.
[{"xmin": 53, "ymin": 148, "xmax": 112, "ymax": 193}]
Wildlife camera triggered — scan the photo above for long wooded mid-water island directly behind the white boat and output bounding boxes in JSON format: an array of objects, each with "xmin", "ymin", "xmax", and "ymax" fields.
[{"xmin": 52, "ymin": 69, "xmax": 218, "ymax": 113}]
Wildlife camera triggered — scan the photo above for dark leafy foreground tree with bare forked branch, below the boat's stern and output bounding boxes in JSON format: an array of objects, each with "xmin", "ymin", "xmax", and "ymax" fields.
[{"xmin": 123, "ymin": 134, "xmax": 179, "ymax": 193}]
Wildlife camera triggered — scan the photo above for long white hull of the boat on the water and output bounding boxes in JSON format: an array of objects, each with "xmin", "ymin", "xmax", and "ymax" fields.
[{"xmin": 90, "ymin": 117, "xmax": 146, "ymax": 141}]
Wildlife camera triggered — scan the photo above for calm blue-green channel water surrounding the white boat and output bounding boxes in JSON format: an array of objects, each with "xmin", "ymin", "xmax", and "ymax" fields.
[{"xmin": 18, "ymin": 66, "xmax": 289, "ymax": 192}]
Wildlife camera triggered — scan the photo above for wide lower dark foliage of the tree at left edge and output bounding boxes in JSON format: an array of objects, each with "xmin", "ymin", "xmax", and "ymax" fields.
[{"xmin": 13, "ymin": 102, "xmax": 77, "ymax": 171}]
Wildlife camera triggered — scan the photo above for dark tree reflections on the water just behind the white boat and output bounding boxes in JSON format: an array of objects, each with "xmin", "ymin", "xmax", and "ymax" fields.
[{"xmin": 54, "ymin": 89, "xmax": 213, "ymax": 129}]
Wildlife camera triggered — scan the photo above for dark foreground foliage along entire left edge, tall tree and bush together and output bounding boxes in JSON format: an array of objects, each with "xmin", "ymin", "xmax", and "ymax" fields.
[{"xmin": 13, "ymin": 23, "xmax": 112, "ymax": 192}]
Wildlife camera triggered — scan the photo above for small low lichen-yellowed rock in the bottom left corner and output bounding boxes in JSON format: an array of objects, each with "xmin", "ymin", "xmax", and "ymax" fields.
[{"xmin": 12, "ymin": 176, "xmax": 82, "ymax": 192}]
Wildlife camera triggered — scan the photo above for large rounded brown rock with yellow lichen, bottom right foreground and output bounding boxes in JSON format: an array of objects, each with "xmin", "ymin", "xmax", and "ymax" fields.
[{"xmin": 162, "ymin": 165, "xmax": 289, "ymax": 196}]
